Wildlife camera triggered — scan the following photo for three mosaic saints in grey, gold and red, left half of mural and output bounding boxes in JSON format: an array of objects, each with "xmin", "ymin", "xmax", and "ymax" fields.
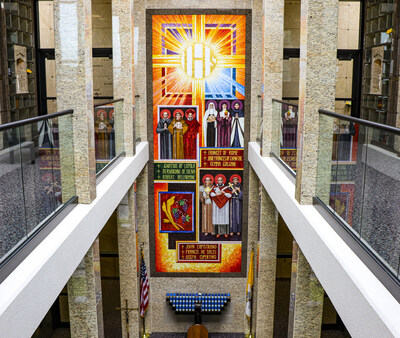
[{"xmin": 156, "ymin": 109, "xmax": 200, "ymax": 159}]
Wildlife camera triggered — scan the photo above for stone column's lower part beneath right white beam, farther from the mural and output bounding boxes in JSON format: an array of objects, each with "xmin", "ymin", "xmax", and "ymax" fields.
[{"xmin": 288, "ymin": 248, "xmax": 324, "ymax": 338}]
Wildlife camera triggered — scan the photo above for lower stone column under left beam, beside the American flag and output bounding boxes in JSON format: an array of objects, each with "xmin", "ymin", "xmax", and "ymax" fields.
[{"xmin": 117, "ymin": 186, "xmax": 139, "ymax": 337}]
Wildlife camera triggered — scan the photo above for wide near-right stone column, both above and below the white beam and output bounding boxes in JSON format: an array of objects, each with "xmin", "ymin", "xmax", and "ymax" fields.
[{"xmin": 288, "ymin": 0, "xmax": 338, "ymax": 337}]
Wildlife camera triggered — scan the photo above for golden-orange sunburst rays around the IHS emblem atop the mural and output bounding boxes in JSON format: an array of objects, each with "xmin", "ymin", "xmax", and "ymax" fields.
[{"xmin": 152, "ymin": 15, "xmax": 245, "ymax": 109}]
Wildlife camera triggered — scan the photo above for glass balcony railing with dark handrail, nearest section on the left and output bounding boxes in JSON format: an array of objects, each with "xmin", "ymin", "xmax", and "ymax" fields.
[{"xmin": 0, "ymin": 110, "xmax": 75, "ymax": 266}]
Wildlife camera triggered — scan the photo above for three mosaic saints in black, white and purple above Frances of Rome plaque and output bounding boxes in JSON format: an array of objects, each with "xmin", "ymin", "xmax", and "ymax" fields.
[{"xmin": 203, "ymin": 101, "xmax": 244, "ymax": 148}]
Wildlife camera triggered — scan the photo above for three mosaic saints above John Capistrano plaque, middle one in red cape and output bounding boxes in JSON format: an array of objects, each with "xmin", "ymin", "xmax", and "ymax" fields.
[{"xmin": 199, "ymin": 174, "xmax": 243, "ymax": 237}]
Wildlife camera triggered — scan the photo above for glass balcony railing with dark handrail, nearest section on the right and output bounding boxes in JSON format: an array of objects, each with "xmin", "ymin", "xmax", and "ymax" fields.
[{"xmin": 316, "ymin": 110, "xmax": 400, "ymax": 279}]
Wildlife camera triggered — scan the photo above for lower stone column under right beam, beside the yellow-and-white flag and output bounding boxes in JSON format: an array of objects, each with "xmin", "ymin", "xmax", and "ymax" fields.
[{"xmin": 256, "ymin": 187, "xmax": 278, "ymax": 337}]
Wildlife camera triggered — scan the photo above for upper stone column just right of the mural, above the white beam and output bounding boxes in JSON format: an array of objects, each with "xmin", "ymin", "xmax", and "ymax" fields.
[{"xmin": 262, "ymin": 0, "xmax": 285, "ymax": 156}]
